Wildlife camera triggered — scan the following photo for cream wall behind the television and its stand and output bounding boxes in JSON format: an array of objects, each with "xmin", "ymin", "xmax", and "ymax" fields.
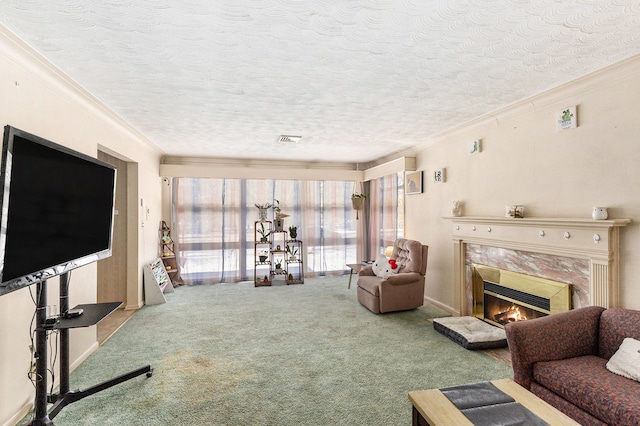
[{"xmin": 0, "ymin": 26, "xmax": 161, "ymax": 425}]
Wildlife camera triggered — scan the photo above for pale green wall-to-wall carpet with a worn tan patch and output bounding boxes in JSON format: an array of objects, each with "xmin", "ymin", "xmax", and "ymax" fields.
[{"xmin": 20, "ymin": 277, "xmax": 512, "ymax": 426}]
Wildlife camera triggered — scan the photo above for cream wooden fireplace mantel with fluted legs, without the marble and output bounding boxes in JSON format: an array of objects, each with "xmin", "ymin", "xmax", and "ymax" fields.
[{"xmin": 446, "ymin": 216, "xmax": 631, "ymax": 315}]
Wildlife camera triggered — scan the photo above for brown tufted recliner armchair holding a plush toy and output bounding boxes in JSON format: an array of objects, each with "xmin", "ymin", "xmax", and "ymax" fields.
[{"xmin": 357, "ymin": 238, "xmax": 429, "ymax": 314}]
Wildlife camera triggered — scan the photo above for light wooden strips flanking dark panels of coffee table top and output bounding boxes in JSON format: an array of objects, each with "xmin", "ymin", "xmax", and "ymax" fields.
[{"xmin": 409, "ymin": 379, "xmax": 580, "ymax": 426}]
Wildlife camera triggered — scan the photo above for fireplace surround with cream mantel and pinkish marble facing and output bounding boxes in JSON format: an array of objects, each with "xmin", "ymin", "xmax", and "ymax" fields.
[{"xmin": 448, "ymin": 216, "xmax": 631, "ymax": 315}]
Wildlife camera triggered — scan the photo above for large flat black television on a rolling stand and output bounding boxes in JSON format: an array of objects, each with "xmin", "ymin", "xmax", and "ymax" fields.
[{"xmin": 0, "ymin": 126, "xmax": 116, "ymax": 295}]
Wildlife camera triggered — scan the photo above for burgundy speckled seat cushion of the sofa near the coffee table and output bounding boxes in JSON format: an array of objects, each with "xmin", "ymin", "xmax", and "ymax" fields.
[{"xmin": 533, "ymin": 355, "xmax": 640, "ymax": 425}]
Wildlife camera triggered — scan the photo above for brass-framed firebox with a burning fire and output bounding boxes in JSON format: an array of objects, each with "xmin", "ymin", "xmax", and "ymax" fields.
[{"xmin": 473, "ymin": 264, "xmax": 571, "ymax": 327}]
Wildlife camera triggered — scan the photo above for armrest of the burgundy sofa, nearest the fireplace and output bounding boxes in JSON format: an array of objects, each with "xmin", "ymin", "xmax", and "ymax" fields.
[{"xmin": 505, "ymin": 306, "xmax": 605, "ymax": 389}]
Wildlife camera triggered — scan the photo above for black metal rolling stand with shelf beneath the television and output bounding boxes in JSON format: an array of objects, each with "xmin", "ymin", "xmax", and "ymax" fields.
[{"xmin": 31, "ymin": 272, "xmax": 153, "ymax": 426}]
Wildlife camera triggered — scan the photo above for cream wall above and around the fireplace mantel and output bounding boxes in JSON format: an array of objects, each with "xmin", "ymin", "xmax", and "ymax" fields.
[{"xmin": 406, "ymin": 53, "xmax": 640, "ymax": 309}]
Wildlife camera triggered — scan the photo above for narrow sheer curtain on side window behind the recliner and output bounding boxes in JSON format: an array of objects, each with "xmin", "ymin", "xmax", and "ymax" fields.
[{"xmin": 365, "ymin": 173, "xmax": 404, "ymax": 259}]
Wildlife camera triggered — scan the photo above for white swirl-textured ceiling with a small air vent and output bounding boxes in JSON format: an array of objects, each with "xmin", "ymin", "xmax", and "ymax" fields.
[{"xmin": 0, "ymin": 0, "xmax": 640, "ymax": 162}]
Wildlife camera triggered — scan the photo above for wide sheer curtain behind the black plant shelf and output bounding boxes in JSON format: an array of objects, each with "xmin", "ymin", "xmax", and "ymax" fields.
[{"xmin": 173, "ymin": 178, "xmax": 359, "ymax": 284}]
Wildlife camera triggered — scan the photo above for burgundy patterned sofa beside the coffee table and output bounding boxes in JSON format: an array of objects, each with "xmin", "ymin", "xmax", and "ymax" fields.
[{"xmin": 505, "ymin": 306, "xmax": 640, "ymax": 426}]
